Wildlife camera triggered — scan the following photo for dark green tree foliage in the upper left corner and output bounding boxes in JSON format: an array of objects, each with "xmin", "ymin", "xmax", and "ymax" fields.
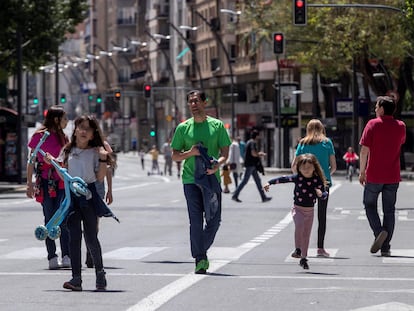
[{"xmin": 0, "ymin": 0, "xmax": 88, "ymax": 74}]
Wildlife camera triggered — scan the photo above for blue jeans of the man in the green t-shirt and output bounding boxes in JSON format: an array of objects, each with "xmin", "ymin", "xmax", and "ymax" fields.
[{"xmin": 184, "ymin": 184, "xmax": 221, "ymax": 262}]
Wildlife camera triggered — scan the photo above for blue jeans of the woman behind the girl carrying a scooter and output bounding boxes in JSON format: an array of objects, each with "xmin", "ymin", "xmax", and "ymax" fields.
[{"xmin": 41, "ymin": 178, "xmax": 69, "ymax": 260}]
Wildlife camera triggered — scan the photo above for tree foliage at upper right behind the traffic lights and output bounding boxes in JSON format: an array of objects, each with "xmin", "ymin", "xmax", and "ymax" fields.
[{"xmin": 241, "ymin": 0, "xmax": 414, "ymax": 111}]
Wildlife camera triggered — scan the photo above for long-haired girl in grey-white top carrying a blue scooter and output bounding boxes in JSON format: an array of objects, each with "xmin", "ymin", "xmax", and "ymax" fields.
[{"xmin": 49, "ymin": 116, "xmax": 116, "ymax": 291}]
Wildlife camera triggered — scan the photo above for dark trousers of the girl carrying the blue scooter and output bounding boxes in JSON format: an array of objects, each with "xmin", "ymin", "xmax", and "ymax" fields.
[{"xmin": 68, "ymin": 184, "xmax": 103, "ymax": 278}]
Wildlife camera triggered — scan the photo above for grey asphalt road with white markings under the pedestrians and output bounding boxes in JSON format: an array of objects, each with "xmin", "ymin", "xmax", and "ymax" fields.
[{"xmin": 0, "ymin": 154, "xmax": 414, "ymax": 311}]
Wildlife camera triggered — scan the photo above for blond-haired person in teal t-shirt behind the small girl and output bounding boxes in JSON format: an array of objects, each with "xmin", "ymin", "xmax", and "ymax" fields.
[{"xmin": 292, "ymin": 119, "xmax": 336, "ymax": 257}]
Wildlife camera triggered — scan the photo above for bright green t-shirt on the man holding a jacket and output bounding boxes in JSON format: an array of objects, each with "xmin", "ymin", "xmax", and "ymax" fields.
[{"xmin": 171, "ymin": 117, "xmax": 231, "ymax": 184}]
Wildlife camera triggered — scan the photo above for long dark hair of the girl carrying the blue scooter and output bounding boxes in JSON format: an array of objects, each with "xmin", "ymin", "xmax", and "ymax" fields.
[{"xmin": 63, "ymin": 115, "xmax": 115, "ymax": 167}]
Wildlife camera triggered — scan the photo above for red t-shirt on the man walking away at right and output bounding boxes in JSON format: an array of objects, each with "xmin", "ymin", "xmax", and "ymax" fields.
[{"xmin": 359, "ymin": 116, "xmax": 405, "ymax": 184}]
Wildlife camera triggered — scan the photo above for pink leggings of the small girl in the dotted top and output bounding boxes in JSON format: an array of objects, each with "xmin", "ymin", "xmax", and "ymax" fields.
[{"xmin": 292, "ymin": 205, "xmax": 313, "ymax": 258}]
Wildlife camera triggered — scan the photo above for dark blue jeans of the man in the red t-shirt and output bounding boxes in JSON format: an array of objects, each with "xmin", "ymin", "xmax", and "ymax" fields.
[{"xmin": 364, "ymin": 183, "xmax": 399, "ymax": 252}]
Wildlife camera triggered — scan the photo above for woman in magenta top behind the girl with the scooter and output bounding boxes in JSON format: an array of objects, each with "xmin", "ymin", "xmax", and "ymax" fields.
[{"xmin": 26, "ymin": 106, "xmax": 71, "ymax": 270}]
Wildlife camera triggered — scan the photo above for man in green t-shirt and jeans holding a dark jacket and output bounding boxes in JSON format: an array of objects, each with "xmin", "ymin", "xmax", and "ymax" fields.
[{"xmin": 171, "ymin": 90, "xmax": 231, "ymax": 274}]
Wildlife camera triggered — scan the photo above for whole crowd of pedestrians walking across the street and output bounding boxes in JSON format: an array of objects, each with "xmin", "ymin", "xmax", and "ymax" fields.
[{"xmin": 26, "ymin": 94, "xmax": 406, "ymax": 291}]
